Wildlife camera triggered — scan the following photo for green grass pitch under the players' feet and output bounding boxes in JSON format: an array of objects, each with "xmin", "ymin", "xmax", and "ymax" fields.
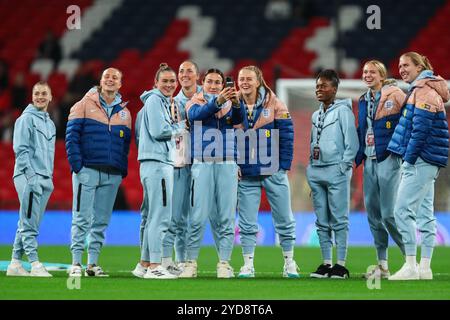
[{"xmin": 0, "ymin": 246, "xmax": 450, "ymax": 300}]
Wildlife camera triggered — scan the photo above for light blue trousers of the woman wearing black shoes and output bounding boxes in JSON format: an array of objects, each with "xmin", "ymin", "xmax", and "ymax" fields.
[{"xmin": 306, "ymin": 164, "xmax": 352, "ymax": 261}]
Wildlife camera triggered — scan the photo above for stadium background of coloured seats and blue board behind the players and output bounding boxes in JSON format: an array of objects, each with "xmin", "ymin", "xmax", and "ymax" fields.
[{"xmin": 0, "ymin": 0, "xmax": 450, "ymax": 245}]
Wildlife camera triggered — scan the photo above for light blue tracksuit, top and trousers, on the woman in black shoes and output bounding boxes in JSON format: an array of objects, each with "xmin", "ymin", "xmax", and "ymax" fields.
[{"xmin": 306, "ymin": 99, "xmax": 359, "ymax": 261}]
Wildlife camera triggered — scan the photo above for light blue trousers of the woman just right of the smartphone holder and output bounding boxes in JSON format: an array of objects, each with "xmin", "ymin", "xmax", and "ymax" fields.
[{"xmin": 238, "ymin": 170, "xmax": 295, "ymax": 254}]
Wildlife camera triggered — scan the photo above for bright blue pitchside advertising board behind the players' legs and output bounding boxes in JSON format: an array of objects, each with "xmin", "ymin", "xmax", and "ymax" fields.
[{"xmin": 0, "ymin": 211, "xmax": 450, "ymax": 247}]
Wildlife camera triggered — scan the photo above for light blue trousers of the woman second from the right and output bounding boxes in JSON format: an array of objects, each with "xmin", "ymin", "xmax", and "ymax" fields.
[{"xmin": 363, "ymin": 155, "xmax": 405, "ymax": 260}]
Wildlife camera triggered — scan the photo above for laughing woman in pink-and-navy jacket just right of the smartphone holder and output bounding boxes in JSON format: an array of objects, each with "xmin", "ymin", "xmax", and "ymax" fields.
[{"xmin": 238, "ymin": 66, "xmax": 299, "ymax": 278}]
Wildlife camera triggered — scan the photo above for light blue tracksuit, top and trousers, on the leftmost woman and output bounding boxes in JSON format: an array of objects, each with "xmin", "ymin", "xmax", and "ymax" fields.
[{"xmin": 12, "ymin": 104, "xmax": 56, "ymax": 262}]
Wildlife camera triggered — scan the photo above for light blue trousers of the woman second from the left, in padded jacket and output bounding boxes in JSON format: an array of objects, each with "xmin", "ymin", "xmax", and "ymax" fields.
[{"xmin": 70, "ymin": 167, "xmax": 122, "ymax": 264}]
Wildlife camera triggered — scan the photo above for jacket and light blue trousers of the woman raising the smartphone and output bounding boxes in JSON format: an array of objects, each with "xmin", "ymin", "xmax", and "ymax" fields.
[{"xmin": 187, "ymin": 92, "xmax": 242, "ymax": 261}]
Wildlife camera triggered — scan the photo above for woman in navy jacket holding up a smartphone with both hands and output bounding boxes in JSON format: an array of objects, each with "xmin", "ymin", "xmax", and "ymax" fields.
[{"xmin": 180, "ymin": 69, "xmax": 243, "ymax": 278}]
